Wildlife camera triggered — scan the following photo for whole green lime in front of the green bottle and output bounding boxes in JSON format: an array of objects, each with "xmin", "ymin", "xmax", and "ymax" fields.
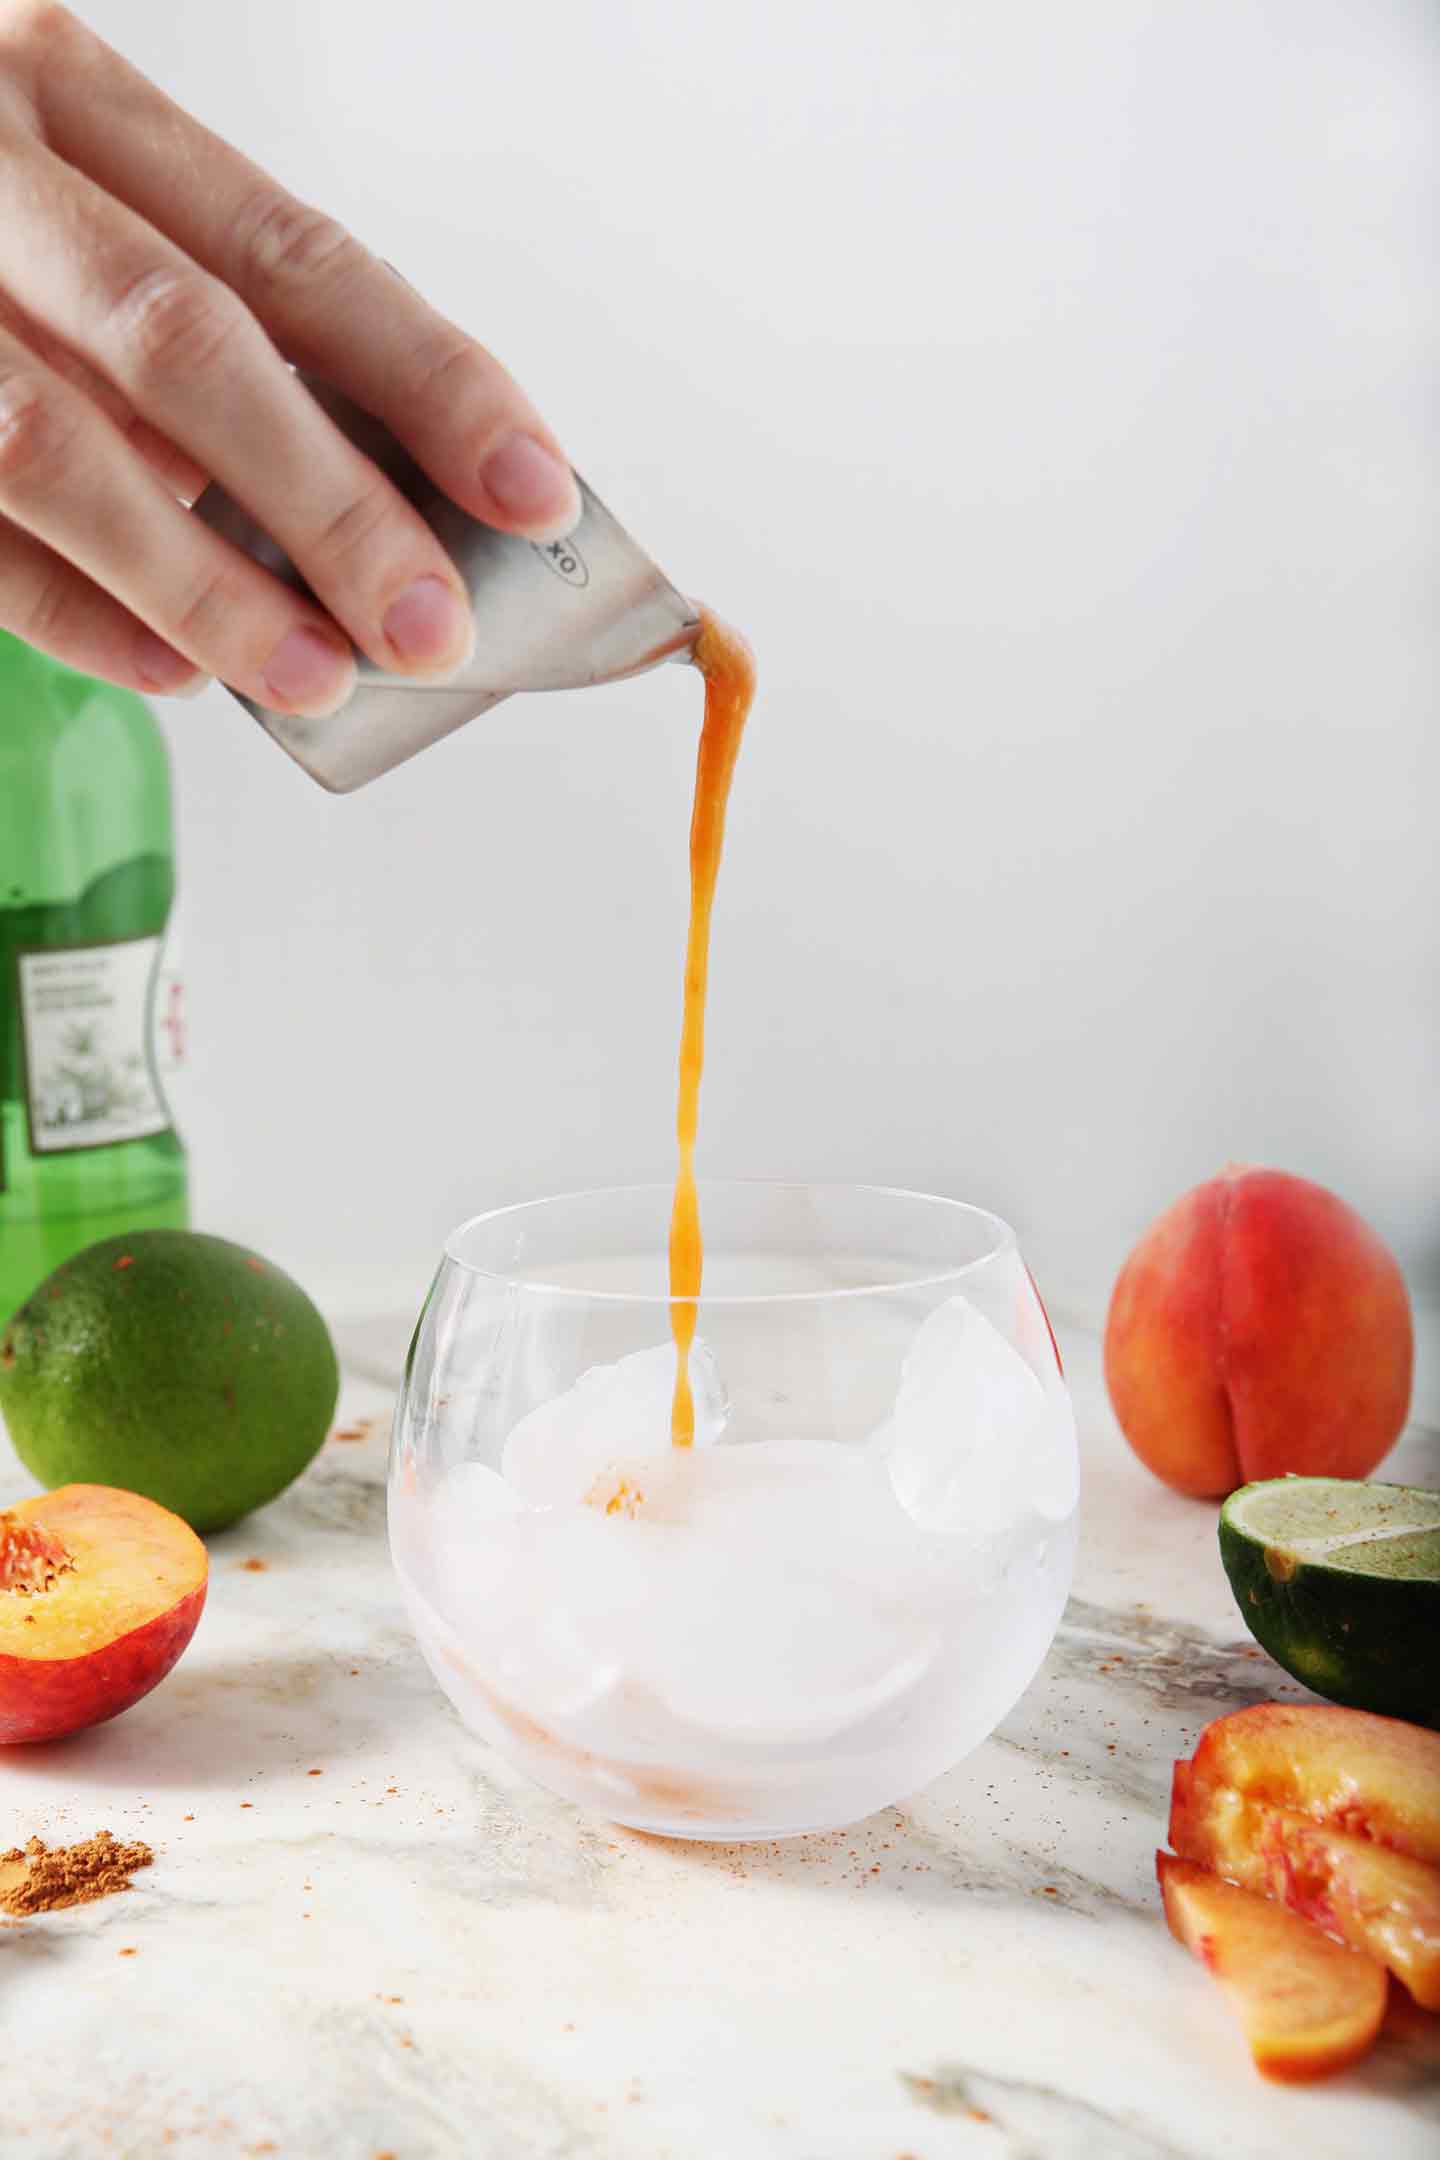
[{"xmin": 0, "ymin": 1229, "xmax": 339, "ymax": 1531}]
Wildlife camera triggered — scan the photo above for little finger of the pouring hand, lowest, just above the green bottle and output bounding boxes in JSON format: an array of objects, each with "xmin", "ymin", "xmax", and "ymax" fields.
[{"xmin": 0, "ymin": 521, "xmax": 205, "ymax": 696}]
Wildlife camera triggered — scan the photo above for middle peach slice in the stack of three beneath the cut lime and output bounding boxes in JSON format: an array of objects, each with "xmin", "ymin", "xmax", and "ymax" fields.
[{"xmin": 1170, "ymin": 1763, "xmax": 1440, "ymax": 2011}]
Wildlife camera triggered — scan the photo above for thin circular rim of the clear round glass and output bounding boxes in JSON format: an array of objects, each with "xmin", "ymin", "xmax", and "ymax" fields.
[{"xmin": 443, "ymin": 1177, "xmax": 1019, "ymax": 1309}]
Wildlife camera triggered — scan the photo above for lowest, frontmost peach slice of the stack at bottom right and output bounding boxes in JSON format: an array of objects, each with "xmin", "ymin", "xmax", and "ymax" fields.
[{"xmin": 1155, "ymin": 1853, "xmax": 1388, "ymax": 2084}]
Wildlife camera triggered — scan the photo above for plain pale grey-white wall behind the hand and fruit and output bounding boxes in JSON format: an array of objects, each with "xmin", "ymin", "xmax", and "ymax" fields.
[{"xmin": 89, "ymin": 0, "xmax": 1440, "ymax": 1365}]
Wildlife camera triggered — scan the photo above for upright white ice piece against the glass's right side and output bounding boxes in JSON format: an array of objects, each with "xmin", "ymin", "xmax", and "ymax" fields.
[{"xmin": 877, "ymin": 1296, "xmax": 1077, "ymax": 1540}]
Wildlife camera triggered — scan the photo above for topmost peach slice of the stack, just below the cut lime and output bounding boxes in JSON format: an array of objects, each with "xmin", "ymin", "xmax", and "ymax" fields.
[{"xmin": 1194, "ymin": 1702, "xmax": 1440, "ymax": 1866}]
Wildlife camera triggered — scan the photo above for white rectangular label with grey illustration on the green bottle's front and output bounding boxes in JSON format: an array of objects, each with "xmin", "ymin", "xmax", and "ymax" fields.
[{"xmin": 17, "ymin": 937, "xmax": 171, "ymax": 1156}]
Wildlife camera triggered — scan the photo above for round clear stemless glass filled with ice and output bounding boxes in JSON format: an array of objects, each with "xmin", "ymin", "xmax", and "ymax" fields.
[{"xmin": 391, "ymin": 1184, "xmax": 1077, "ymax": 1838}]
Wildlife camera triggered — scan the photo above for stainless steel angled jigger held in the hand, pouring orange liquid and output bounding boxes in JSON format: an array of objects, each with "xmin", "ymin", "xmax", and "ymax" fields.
[{"xmin": 194, "ymin": 376, "xmax": 699, "ymax": 795}]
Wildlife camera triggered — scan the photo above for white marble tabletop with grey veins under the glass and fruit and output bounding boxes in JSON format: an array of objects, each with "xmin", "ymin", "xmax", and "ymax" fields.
[{"xmin": 0, "ymin": 1326, "xmax": 1440, "ymax": 2160}]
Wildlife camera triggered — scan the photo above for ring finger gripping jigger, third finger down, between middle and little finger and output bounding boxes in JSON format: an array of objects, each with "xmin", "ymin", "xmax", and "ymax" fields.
[{"xmin": 0, "ymin": 330, "xmax": 354, "ymax": 717}]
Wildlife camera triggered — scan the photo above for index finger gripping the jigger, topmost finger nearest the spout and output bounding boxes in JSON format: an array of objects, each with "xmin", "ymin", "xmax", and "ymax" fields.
[{"xmin": 25, "ymin": 19, "xmax": 581, "ymax": 540}]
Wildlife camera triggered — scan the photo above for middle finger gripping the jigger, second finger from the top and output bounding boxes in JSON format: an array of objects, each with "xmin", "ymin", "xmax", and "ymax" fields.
[{"xmin": 0, "ymin": 143, "xmax": 483, "ymax": 674}]
